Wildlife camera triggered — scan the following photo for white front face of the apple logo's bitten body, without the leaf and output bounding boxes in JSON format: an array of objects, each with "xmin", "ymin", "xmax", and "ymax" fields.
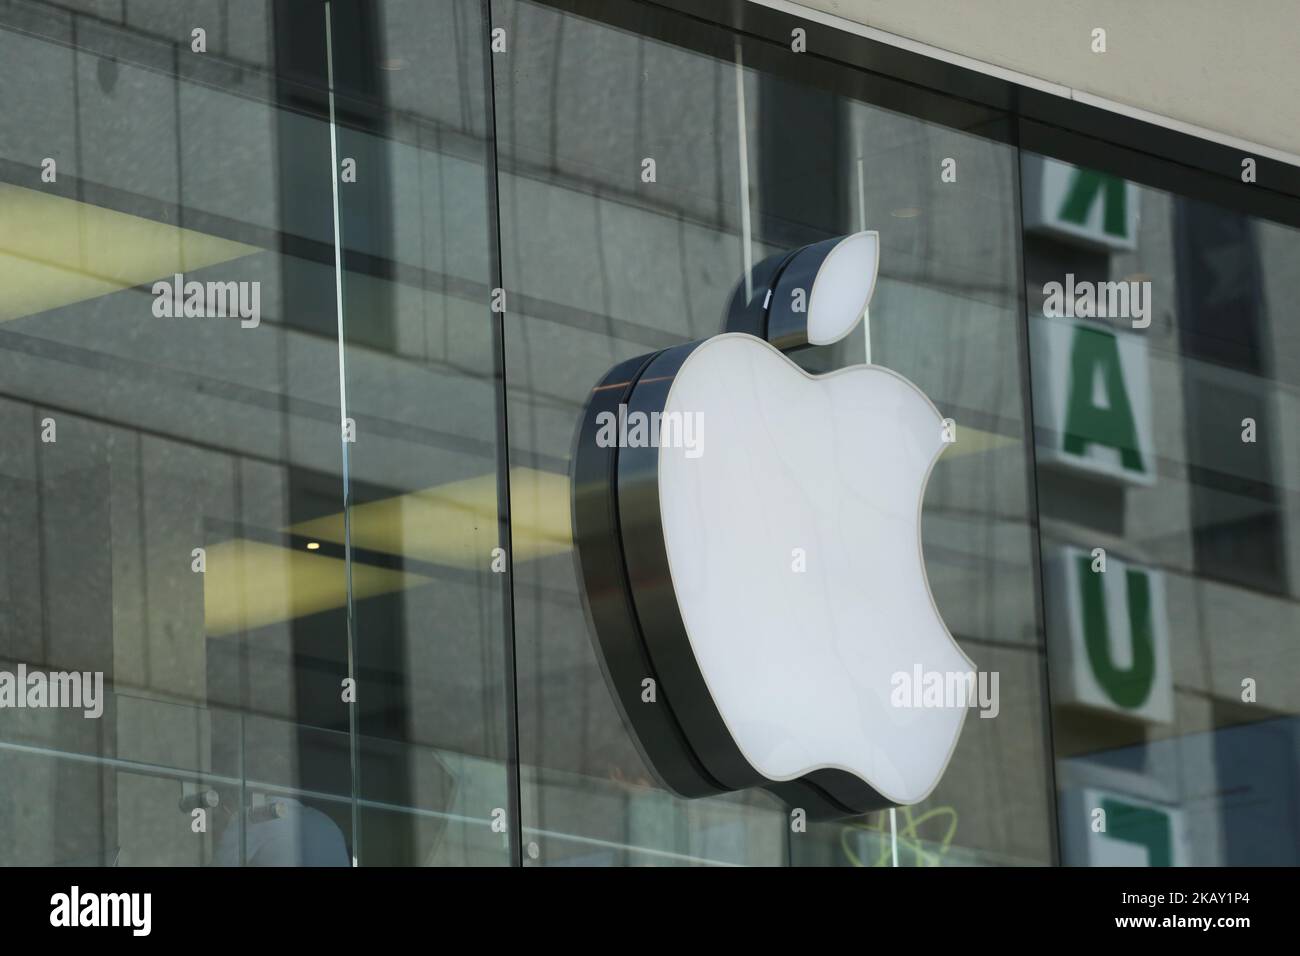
[{"xmin": 658, "ymin": 332, "xmax": 974, "ymax": 804}]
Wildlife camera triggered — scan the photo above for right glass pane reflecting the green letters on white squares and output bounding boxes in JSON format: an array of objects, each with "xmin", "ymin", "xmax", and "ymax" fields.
[{"xmin": 1023, "ymin": 152, "xmax": 1300, "ymax": 866}]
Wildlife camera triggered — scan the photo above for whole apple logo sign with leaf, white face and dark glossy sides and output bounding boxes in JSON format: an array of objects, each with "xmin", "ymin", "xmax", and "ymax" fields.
[{"xmin": 572, "ymin": 232, "xmax": 974, "ymax": 817}]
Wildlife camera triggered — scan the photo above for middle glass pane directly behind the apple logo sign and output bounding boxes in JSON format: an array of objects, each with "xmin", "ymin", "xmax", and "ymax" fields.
[{"xmin": 493, "ymin": 3, "xmax": 1053, "ymax": 865}]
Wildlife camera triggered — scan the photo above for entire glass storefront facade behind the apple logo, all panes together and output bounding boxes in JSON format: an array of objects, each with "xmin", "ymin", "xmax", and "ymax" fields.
[{"xmin": 0, "ymin": 0, "xmax": 1300, "ymax": 866}]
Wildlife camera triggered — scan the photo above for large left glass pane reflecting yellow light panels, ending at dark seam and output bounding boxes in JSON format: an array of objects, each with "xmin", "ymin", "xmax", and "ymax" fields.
[{"xmin": 0, "ymin": 0, "xmax": 510, "ymax": 865}]
